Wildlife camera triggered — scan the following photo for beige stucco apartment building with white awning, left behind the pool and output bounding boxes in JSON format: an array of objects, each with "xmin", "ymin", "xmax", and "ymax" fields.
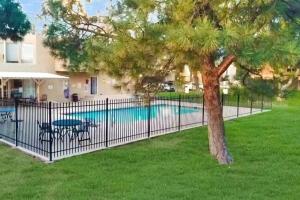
[{"xmin": 0, "ymin": 34, "xmax": 129, "ymax": 101}]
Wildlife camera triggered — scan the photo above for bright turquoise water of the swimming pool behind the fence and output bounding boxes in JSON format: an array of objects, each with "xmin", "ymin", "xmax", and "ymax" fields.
[{"xmin": 68, "ymin": 104, "xmax": 201, "ymax": 122}]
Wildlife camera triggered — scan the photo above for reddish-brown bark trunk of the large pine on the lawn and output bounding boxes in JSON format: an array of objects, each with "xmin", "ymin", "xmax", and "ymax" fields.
[{"xmin": 202, "ymin": 57, "xmax": 233, "ymax": 164}]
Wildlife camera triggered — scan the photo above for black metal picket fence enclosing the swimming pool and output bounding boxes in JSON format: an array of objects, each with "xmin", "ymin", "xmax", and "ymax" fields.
[{"xmin": 0, "ymin": 95, "xmax": 272, "ymax": 161}]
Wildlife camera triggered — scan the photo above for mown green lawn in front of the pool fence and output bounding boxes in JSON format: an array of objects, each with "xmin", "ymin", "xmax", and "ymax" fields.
[{"xmin": 0, "ymin": 93, "xmax": 300, "ymax": 200}]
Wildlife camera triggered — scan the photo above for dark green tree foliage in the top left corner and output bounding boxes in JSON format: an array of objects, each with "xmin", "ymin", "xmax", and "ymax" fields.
[{"xmin": 0, "ymin": 0, "xmax": 31, "ymax": 41}]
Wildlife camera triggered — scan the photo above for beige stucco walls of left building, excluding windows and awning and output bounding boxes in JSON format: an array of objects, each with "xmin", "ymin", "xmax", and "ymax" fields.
[{"xmin": 0, "ymin": 34, "xmax": 129, "ymax": 101}]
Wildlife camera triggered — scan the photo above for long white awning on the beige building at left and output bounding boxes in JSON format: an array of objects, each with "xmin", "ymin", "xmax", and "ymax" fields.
[{"xmin": 0, "ymin": 72, "xmax": 69, "ymax": 79}]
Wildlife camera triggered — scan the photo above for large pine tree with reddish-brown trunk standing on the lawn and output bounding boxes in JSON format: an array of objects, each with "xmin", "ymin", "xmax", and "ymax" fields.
[{"xmin": 44, "ymin": 0, "xmax": 300, "ymax": 164}]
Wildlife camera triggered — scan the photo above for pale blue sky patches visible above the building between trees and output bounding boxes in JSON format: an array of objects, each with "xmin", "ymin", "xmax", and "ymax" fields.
[{"xmin": 18, "ymin": 0, "xmax": 111, "ymax": 31}]
